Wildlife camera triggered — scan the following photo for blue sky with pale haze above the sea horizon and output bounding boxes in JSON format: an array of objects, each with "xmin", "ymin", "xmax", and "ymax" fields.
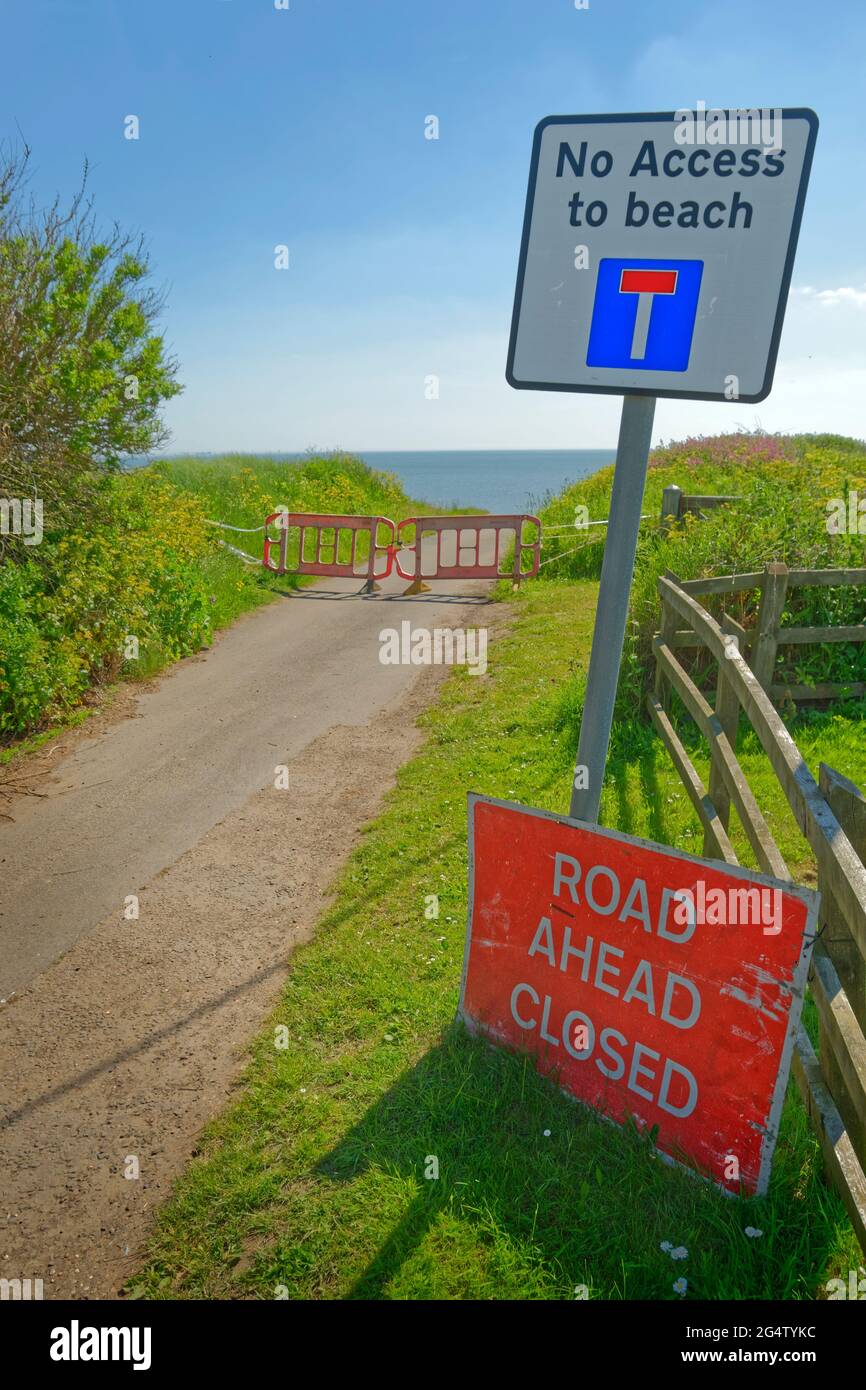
[{"xmin": 0, "ymin": 0, "xmax": 866, "ymax": 450}]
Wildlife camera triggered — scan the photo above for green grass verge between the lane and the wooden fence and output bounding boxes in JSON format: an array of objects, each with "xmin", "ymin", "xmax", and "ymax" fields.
[{"xmin": 132, "ymin": 581, "xmax": 866, "ymax": 1300}]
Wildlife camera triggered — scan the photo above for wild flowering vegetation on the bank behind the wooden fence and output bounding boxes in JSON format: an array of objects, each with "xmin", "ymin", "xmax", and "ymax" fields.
[{"xmin": 541, "ymin": 434, "xmax": 866, "ymax": 733}]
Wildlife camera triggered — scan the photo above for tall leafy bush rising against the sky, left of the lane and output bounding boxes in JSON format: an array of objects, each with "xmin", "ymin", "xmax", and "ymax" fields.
[{"xmin": 0, "ymin": 149, "xmax": 181, "ymax": 547}]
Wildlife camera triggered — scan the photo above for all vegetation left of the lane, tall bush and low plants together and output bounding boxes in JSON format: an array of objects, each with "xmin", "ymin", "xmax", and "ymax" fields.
[{"xmin": 0, "ymin": 147, "xmax": 419, "ymax": 745}]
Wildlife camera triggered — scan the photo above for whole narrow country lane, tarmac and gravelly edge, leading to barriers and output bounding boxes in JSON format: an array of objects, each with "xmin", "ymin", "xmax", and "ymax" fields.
[{"xmin": 0, "ymin": 558, "xmax": 492, "ymax": 1298}]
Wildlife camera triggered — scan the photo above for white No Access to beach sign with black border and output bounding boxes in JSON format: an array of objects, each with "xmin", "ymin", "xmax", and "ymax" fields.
[{"xmin": 506, "ymin": 108, "xmax": 817, "ymax": 400}]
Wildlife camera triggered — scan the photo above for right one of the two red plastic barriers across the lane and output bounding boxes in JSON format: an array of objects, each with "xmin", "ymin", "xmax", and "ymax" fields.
[{"xmin": 395, "ymin": 514, "xmax": 541, "ymax": 592}]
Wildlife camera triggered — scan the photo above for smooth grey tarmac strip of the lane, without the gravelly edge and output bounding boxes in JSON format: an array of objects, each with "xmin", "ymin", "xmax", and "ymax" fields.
[{"xmin": 0, "ymin": 553, "xmax": 489, "ymax": 998}]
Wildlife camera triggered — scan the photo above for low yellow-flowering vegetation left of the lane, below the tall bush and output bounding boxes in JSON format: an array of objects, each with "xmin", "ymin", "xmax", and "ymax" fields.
[{"xmin": 0, "ymin": 455, "xmax": 410, "ymax": 741}]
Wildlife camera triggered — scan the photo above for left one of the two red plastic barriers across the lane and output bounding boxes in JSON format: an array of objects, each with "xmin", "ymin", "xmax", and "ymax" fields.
[{"xmin": 261, "ymin": 512, "xmax": 396, "ymax": 594}]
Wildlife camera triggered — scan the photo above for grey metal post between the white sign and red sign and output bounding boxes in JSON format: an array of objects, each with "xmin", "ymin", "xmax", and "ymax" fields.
[{"xmin": 569, "ymin": 396, "xmax": 656, "ymax": 821}]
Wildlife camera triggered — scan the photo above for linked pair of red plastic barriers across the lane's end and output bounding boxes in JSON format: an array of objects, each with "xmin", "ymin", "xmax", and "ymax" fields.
[{"xmin": 261, "ymin": 512, "xmax": 541, "ymax": 594}]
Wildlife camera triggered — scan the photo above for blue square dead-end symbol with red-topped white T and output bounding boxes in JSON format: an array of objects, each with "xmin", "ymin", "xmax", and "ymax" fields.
[{"xmin": 587, "ymin": 257, "xmax": 703, "ymax": 371}]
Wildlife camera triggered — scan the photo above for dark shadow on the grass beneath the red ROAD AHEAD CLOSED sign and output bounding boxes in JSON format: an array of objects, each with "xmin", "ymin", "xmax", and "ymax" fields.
[{"xmin": 314, "ymin": 1023, "xmax": 838, "ymax": 1300}]
